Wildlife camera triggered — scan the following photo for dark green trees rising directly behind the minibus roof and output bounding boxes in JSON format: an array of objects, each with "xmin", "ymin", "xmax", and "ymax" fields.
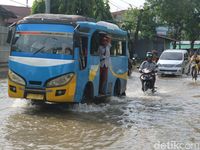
[{"xmin": 32, "ymin": 0, "xmax": 112, "ymax": 21}]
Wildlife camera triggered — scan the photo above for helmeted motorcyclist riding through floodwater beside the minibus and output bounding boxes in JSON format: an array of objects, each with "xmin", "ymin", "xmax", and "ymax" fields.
[{"xmin": 139, "ymin": 52, "xmax": 156, "ymax": 92}]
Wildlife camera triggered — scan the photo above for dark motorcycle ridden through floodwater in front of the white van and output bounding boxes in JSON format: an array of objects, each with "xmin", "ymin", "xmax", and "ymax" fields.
[{"xmin": 140, "ymin": 68, "xmax": 156, "ymax": 93}]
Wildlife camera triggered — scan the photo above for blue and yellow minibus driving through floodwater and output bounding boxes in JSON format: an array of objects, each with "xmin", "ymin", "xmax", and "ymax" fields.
[{"xmin": 7, "ymin": 14, "xmax": 128, "ymax": 103}]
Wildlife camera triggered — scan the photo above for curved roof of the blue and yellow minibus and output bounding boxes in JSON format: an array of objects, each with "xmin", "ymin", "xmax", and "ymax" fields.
[{"xmin": 18, "ymin": 14, "xmax": 127, "ymax": 35}]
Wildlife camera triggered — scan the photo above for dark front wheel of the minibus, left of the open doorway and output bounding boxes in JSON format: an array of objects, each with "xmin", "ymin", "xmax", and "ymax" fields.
[{"xmin": 81, "ymin": 83, "xmax": 94, "ymax": 103}]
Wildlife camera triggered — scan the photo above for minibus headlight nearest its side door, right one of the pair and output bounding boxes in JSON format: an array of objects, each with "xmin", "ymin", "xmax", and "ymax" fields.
[{"xmin": 46, "ymin": 73, "xmax": 74, "ymax": 87}]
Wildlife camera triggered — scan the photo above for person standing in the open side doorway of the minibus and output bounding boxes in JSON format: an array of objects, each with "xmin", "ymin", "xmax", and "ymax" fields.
[{"xmin": 99, "ymin": 34, "xmax": 111, "ymax": 95}]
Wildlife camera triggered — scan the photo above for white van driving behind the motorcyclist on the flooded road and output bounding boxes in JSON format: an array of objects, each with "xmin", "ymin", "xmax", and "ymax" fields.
[{"xmin": 157, "ymin": 49, "xmax": 189, "ymax": 75}]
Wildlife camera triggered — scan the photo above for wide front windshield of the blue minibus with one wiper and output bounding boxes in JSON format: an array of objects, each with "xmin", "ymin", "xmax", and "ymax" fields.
[{"xmin": 11, "ymin": 32, "xmax": 73, "ymax": 55}]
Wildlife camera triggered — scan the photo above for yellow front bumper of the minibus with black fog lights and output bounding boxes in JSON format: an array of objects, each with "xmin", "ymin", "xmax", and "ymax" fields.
[{"xmin": 8, "ymin": 76, "xmax": 76, "ymax": 102}]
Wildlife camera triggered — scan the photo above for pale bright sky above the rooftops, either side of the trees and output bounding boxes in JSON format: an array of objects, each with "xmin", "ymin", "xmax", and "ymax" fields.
[{"xmin": 0, "ymin": 0, "xmax": 145, "ymax": 12}]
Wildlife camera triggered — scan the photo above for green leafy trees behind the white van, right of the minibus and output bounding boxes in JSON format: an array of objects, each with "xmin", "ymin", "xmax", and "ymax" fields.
[{"xmin": 123, "ymin": 0, "xmax": 200, "ymax": 51}]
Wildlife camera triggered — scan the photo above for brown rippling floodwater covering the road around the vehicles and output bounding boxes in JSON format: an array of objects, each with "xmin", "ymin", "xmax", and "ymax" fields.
[{"xmin": 0, "ymin": 73, "xmax": 200, "ymax": 150}]
